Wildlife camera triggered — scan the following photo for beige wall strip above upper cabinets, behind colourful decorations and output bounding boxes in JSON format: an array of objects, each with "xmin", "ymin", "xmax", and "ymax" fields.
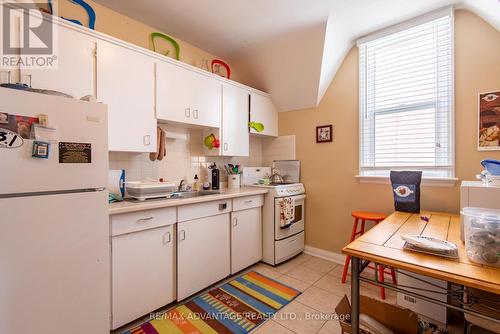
[{"xmin": 42, "ymin": 0, "xmax": 230, "ymax": 72}]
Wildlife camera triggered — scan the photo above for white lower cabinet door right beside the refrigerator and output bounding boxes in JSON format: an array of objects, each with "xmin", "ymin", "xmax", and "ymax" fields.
[{"xmin": 112, "ymin": 225, "xmax": 175, "ymax": 329}]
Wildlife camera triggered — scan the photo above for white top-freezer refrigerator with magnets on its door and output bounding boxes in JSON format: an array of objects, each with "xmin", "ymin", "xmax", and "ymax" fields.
[{"xmin": 0, "ymin": 88, "xmax": 111, "ymax": 334}]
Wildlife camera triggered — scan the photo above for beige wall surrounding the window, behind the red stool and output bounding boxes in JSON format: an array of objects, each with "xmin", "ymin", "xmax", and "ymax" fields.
[{"xmin": 279, "ymin": 10, "xmax": 500, "ymax": 252}]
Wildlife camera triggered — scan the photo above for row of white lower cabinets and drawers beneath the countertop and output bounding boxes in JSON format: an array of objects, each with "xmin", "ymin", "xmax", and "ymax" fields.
[{"xmin": 110, "ymin": 195, "xmax": 264, "ymax": 329}]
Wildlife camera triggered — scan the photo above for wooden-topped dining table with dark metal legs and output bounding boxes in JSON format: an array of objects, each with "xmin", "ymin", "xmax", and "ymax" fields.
[{"xmin": 342, "ymin": 211, "xmax": 500, "ymax": 333}]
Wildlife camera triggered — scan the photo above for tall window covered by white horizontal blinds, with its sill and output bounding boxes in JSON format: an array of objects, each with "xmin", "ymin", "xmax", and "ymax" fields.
[{"xmin": 358, "ymin": 10, "xmax": 454, "ymax": 178}]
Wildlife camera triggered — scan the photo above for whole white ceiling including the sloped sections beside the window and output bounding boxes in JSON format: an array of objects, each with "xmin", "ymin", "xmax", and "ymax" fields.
[{"xmin": 96, "ymin": 0, "xmax": 500, "ymax": 111}]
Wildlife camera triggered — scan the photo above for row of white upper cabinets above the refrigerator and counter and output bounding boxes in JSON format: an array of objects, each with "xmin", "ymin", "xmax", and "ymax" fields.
[{"xmin": 0, "ymin": 18, "xmax": 278, "ymax": 151}]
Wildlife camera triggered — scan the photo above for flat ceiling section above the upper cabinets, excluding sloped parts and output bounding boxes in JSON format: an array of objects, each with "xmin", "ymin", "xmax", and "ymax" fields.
[{"xmin": 96, "ymin": 0, "xmax": 332, "ymax": 59}]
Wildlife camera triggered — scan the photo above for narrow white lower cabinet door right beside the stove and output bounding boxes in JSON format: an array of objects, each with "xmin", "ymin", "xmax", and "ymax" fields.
[{"xmin": 231, "ymin": 207, "xmax": 262, "ymax": 274}]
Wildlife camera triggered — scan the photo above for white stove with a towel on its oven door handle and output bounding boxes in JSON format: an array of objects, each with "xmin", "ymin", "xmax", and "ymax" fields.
[{"xmin": 243, "ymin": 167, "xmax": 306, "ymax": 266}]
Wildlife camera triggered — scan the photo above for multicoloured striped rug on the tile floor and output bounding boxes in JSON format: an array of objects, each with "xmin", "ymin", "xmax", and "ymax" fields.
[{"xmin": 123, "ymin": 271, "xmax": 300, "ymax": 334}]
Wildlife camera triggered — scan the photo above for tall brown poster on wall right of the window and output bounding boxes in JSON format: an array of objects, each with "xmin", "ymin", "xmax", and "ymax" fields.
[{"xmin": 478, "ymin": 91, "xmax": 500, "ymax": 151}]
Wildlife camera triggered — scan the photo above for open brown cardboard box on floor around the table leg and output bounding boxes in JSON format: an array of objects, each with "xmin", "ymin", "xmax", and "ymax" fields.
[{"xmin": 335, "ymin": 296, "xmax": 418, "ymax": 334}]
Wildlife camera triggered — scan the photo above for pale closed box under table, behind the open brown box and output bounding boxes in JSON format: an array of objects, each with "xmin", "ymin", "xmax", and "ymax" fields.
[{"xmin": 397, "ymin": 270, "xmax": 448, "ymax": 325}]
